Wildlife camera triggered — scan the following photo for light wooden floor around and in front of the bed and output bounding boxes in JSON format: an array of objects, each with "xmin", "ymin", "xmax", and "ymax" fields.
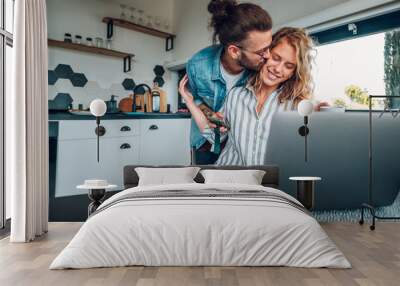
[{"xmin": 0, "ymin": 223, "xmax": 400, "ymax": 286}]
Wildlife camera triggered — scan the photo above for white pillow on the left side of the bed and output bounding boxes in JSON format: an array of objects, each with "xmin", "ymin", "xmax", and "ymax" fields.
[{"xmin": 135, "ymin": 167, "xmax": 200, "ymax": 186}]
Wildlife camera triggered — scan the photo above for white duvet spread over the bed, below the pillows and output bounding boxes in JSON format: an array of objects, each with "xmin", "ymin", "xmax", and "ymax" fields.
[{"xmin": 50, "ymin": 183, "xmax": 351, "ymax": 269}]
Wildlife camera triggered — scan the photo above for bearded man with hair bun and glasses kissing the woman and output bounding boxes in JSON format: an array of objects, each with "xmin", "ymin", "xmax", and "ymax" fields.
[{"xmin": 183, "ymin": 0, "xmax": 272, "ymax": 164}]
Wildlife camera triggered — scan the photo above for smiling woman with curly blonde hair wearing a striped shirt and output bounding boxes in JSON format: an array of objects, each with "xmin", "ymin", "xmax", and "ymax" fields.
[{"xmin": 179, "ymin": 28, "xmax": 313, "ymax": 165}]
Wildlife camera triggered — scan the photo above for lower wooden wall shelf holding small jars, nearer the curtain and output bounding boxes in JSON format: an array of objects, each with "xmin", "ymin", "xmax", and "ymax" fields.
[{"xmin": 47, "ymin": 39, "xmax": 135, "ymax": 72}]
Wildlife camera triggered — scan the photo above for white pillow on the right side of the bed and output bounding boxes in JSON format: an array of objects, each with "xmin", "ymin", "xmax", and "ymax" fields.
[{"xmin": 200, "ymin": 169, "xmax": 265, "ymax": 185}]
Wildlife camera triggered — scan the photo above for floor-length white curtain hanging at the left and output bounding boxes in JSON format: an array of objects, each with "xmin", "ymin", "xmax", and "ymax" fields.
[{"xmin": 6, "ymin": 0, "xmax": 48, "ymax": 242}]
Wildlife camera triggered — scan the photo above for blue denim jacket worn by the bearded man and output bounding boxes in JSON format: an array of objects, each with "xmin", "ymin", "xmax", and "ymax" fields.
[{"xmin": 186, "ymin": 45, "xmax": 249, "ymax": 149}]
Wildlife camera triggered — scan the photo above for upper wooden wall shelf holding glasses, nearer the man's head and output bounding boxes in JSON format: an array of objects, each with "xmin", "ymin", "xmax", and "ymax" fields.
[{"xmin": 103, "ymin": 17, "xmax": 176, "ymax": 51}]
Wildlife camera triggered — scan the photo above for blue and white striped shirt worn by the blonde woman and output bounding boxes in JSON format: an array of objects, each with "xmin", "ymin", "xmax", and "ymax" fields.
[{"xmin": 208, "ymin": 86, "xmax": 293, "ymax": 166}]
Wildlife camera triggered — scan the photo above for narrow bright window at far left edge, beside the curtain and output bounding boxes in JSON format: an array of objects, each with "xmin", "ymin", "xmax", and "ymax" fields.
[{"xmin": 0, "ymin": 0, "xmax": 14, "ymax": 228}]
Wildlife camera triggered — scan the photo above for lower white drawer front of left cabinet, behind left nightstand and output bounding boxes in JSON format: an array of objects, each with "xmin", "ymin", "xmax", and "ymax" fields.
[{"xmin": 56, "ymin": 137, "xmax": 140, "ymax": 196}]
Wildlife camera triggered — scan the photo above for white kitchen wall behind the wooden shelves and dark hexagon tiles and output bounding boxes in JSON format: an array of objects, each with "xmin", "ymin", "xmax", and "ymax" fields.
[{"xmin": 47, "ymin": 0, "xmax": 177, "ymax": 110}]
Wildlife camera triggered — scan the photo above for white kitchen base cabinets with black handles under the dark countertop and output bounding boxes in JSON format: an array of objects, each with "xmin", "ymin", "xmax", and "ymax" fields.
[{"xmin": 55, "ymin": 118, "xmax": 190, "ymax": 197}]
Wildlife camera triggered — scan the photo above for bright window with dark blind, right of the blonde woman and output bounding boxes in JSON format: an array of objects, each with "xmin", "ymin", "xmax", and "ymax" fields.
[{"xmin": 312, "ymin": 8, "xmax": 400, "ymax": 110}]
